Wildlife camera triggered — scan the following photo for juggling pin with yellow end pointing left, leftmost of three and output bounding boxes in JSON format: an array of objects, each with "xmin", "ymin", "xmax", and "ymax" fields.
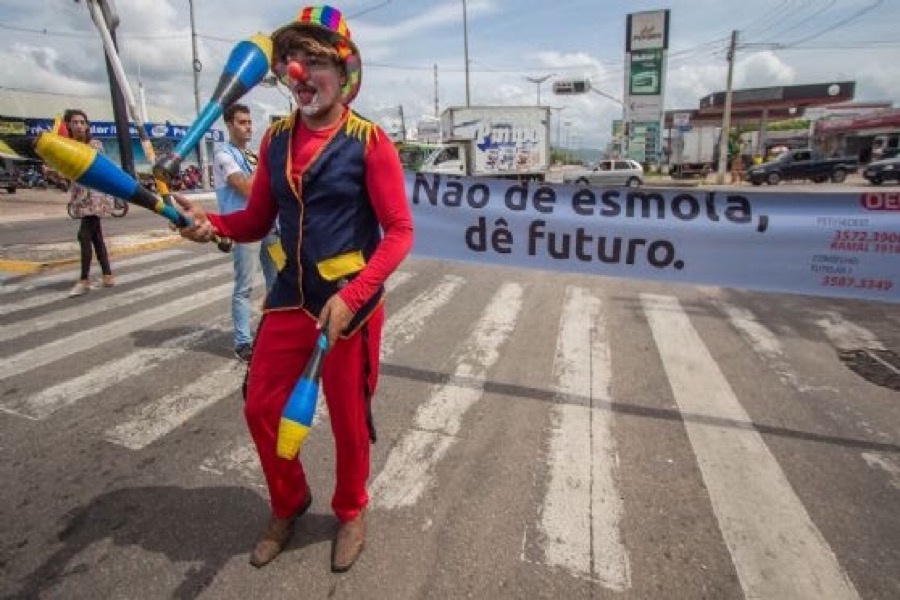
[{"xmin": 34, "ymin": 132, "xmax": 191, "ymax": 227}]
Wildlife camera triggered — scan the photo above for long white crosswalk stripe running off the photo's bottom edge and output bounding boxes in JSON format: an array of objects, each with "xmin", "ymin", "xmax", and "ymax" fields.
[{"xmin": 641, "ymin": 294, "xmax": 858, "ymax": 599}]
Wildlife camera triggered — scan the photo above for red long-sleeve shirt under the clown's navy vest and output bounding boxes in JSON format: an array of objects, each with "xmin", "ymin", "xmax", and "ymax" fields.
[{"xmin": 209, "ymin": 114, "xmax": 413, "ymax": 312}]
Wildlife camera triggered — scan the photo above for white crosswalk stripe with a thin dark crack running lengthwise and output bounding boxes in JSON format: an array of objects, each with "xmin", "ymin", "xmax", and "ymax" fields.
[{"xmin": 528, "ymin": 288, "xmax": 630, "ymax": 591}]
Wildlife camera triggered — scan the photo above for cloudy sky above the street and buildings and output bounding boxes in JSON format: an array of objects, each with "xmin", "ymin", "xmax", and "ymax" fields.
[{"xmin": 0, "ymin": 0, "xmax": 900, "ymax": 148}]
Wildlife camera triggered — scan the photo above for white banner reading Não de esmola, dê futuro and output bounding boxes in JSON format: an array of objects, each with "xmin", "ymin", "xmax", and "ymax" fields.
[{"xmin": 406, "ymin": 173, "xmax": 900, "ymax": 302}]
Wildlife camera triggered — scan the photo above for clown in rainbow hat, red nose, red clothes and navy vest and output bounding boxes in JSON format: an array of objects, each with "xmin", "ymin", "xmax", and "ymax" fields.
[{"xmin": 178, "ymin": 6, "xmax": 412, "ymax": 572}]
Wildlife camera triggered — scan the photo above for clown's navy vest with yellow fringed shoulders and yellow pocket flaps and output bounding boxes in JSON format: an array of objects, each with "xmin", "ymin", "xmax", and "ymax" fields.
[{"xmin": 265, "ymin": 110, "xmax": 384, "ymax": 334}]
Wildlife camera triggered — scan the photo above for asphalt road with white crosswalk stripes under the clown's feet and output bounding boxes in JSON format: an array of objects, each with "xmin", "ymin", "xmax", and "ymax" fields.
[{"xmin": 0, "ymin": 240, "xmax": 900, "ymax": 599}]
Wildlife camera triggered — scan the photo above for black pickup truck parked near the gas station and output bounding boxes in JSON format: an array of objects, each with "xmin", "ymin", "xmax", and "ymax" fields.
[{"xmin": 747, "ymin": 148, "xmax": 858, "ymax": 185}]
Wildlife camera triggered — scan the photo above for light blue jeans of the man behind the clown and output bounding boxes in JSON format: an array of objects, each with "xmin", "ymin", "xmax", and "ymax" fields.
[{"xmin": 231, "ymin": 234, "xmax": 278, "ymax": 348}]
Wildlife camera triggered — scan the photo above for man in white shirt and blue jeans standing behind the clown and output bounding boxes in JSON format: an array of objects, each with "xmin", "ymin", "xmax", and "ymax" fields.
[{"xmin": 214, "ymin": 103, "xmax": 278, "ymax": 362}]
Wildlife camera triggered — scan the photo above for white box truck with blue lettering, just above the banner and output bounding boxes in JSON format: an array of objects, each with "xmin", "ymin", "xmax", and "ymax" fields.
[{"xmin": 419, "ymin": 106, "xmax": 550, "ymax": 181}]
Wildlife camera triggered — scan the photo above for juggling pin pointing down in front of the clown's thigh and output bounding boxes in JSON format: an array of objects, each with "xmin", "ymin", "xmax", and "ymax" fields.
[{"xmin": 275, "ymin": 323, "xmax": 328, "ymax": 460}]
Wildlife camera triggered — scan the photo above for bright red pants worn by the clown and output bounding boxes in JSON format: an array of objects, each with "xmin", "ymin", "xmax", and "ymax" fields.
[{"xmin": 244, "ymin": 306, "xmax": 384, "ymax": 523}]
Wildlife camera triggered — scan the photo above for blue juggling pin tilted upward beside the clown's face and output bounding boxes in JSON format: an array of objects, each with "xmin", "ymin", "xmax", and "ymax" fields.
[{"xmin": 153, "ymin": 33, "xmax": 272, "ymax": 176}]
